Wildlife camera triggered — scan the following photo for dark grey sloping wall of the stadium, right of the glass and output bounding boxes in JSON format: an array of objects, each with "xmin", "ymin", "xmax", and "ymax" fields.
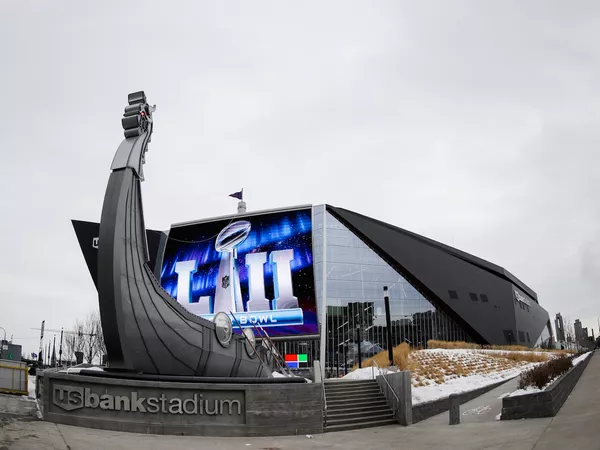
[{"xmin": 327, "ymin": 206, "xmax": 548, "ymax": 345}]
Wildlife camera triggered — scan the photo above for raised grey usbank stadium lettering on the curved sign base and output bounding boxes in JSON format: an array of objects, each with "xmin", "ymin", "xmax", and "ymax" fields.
[{"xmin": 52, "ymin": 384, "xmax": 243, "ymax": 416}]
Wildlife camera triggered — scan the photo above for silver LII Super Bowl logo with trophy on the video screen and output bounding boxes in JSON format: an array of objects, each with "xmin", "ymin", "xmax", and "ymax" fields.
[{"xmin": 175, "ymin": 220, "xmax": 304, "ymax": 327}]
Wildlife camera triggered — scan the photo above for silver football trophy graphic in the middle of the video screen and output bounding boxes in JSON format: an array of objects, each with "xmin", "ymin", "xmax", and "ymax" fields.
[{"xmin": 214, "ymin": 220, "xmax": 250, "ymax": 314}]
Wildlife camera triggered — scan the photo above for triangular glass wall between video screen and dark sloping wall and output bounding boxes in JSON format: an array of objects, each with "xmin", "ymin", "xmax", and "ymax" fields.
[{"xmin": 313, "ymin": 206, "xmax": 471, "ymax": 377}]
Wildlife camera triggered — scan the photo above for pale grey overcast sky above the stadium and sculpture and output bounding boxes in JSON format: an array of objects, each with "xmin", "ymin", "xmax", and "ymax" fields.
[{"xmin": 0, "ymin": 0, "xmax": 600, "ymax": 351}]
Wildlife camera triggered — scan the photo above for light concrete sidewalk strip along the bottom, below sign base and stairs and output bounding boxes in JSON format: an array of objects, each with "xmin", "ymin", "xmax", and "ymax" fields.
[{"xmin": 0, "ymin": 419, "xmax": 550, "ymax": 450}]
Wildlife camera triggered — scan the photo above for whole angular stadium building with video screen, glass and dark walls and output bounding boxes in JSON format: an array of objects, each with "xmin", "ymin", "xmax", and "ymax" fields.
[{"xmin": 73, "ymin": 205, "xmax": 553, "ymax": 377}]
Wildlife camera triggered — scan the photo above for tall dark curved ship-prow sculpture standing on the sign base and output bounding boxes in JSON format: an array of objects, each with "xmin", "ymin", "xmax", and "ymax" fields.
[{"xmin": 98, "ymin": 92, "xmax": 272, "ymax": 377}]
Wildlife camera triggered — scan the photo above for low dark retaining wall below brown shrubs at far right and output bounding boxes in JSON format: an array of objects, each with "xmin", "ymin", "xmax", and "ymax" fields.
[{"xmin": 501, "ymin": 353, "xmax": 593, "ymax": 420}]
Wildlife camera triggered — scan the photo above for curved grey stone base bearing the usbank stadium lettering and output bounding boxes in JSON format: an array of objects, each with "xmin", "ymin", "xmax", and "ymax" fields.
[{"xmin": 38, "ymin": 372, "xmax": 323, "ymax": 436}]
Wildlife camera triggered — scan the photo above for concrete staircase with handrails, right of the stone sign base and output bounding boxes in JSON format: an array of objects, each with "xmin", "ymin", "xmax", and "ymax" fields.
[{"xmin": 324, "ymin": 380, "xmax": 398, "ymax": 433}]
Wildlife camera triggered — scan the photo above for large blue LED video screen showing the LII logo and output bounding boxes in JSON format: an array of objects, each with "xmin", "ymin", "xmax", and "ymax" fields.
[{"xmin": 161, "ymin": 208, "xmax": 318, "ymax": 337}]
